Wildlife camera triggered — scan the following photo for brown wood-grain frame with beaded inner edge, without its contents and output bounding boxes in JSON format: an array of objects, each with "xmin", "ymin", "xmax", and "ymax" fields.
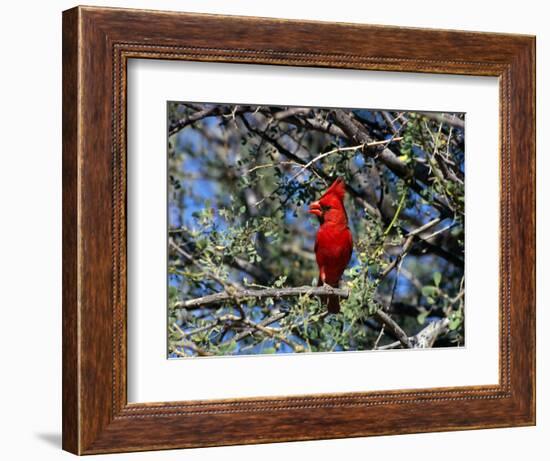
[{"xmin": 62, "ymin": 7, "xmax": 535, "ymax": 454}]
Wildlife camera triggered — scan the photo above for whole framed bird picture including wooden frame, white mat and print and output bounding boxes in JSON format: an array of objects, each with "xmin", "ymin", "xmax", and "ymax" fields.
[{"xmin": 63, "ymin": 7, "xmax": 535, "ymax": 454}]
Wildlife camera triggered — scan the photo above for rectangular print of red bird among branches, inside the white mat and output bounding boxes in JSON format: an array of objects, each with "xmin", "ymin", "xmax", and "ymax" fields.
[{"xmin": 166, "ymin": 101, "xmax": 466, "ymax": 359}]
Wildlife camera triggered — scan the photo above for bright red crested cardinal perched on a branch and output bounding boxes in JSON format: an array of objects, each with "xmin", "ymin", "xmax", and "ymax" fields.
[{"xmin": 309, "ymin": 178, "xmax": 353, "ymax": 313}]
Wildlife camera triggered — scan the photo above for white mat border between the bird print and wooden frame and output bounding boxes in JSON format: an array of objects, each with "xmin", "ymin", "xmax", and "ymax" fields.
[{"xmin": 127, "ymin": 59, "xmax": 499, "ymax": 402}]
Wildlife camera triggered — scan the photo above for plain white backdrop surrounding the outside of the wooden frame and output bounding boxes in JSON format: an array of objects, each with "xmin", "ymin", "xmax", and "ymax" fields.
[{"xmin": 0, "ymin": 0, "xmax": 550, "ymax": 460}]
